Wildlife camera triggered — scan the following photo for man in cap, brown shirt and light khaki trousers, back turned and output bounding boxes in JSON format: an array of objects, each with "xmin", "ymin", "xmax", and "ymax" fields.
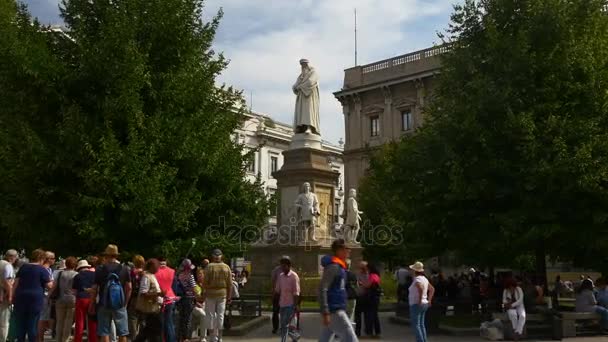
[{"xmin": 203, "ymin": 249, "xmax": 232, "ymax": 342}]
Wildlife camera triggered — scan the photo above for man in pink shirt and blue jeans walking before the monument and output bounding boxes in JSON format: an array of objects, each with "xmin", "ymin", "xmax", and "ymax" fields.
[{"xmin": 275, "ymin": 257, "xmax": 300, "ymax": 342}]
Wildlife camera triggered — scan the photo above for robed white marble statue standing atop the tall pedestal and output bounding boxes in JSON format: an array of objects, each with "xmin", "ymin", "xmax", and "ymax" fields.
[{"xmin": 292, "ymin": 59, "xmax": 321, "ymax": 135}]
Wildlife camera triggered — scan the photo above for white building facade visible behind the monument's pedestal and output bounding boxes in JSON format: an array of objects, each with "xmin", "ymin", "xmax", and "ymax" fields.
[{"xmin": 235, "ymin": 111, "xmax": 345, "ymax": 227}]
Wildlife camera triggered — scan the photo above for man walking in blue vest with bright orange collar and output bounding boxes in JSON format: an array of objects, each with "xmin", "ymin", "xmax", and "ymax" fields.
[{"xmin": 319, "ymin": 239, "xmax": 358, "ymax": 342}]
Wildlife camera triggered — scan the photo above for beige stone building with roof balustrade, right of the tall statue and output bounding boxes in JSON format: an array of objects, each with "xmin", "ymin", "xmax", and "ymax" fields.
[{"xmin": 334, "ymin": 46, "xmax": 447, "ymax": 189}]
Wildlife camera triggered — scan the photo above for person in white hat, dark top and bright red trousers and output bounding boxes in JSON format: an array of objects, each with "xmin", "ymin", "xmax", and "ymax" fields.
[{"xmin": 72, "ymin": 259, "xmax": 97, "ymax": 342}]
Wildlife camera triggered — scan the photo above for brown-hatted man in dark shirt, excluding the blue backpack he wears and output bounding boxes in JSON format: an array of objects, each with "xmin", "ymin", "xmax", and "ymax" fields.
[{"xmin": 92, "ymin": 245, "xmax": 132, "ymax": 342}]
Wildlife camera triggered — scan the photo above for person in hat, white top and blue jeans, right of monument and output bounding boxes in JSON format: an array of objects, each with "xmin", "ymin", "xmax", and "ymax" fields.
[{"xmin": 408, "ymin": 261, "xmax": 435, "ymax": 342}]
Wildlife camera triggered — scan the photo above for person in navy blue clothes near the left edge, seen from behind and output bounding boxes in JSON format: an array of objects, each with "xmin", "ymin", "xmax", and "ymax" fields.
[{"xmin": 13, "ymin": 249, "xmax": 53, "ymax": 342}]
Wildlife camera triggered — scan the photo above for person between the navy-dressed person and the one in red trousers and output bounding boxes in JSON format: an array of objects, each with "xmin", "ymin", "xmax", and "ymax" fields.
[{"xmin": 54, "ymin": 257, "xmax": 78, "ymax": 342}]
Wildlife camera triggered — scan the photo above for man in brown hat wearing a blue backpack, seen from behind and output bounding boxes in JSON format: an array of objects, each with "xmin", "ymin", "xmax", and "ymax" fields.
[{"xmin": 92, "ymin": 244, "xmax": 132, "ymax": 342}]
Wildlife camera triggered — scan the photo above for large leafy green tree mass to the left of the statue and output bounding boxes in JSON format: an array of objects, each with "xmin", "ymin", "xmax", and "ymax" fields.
[{"xmin": 0, "ymin": 0, "xmax": 268, "ymax": 256}]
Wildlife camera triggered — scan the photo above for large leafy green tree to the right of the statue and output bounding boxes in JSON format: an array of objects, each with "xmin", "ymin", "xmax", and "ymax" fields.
[{"xmin": 362, "ymin": 0, "xmax": 608, "ymax": 273}]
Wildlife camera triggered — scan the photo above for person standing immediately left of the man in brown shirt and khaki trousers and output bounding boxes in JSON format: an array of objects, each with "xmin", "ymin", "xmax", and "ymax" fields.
[{"xmin": 177, "ymin": 259, "xmax": 196, "ymax": 342}]
